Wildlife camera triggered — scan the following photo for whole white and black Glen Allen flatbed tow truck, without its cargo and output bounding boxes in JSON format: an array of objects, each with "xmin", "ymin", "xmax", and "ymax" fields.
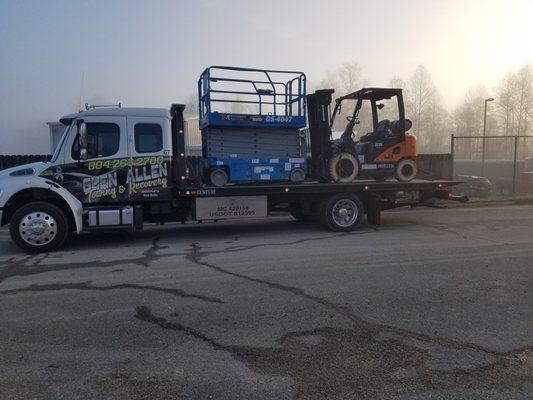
[{"xmin": 0, "ymin": 69, "xmax": 466, "ymax": 252}]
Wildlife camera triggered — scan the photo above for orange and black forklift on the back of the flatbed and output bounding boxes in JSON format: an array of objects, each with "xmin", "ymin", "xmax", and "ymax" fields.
[{"xmin": 307, "ymin": 88, "xmax": 418, "ymax": 182}]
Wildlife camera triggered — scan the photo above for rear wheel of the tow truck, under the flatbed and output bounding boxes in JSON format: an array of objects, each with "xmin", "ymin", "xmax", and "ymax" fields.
[{"xmin": 319, "ymin": 193, "xmax": 365, "ymax": 232}]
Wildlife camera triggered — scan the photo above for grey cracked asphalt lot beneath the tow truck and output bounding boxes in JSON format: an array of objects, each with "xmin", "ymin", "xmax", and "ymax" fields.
[{"xmin": 0, "ymin": 205, "xmax": 533, "ymax": 400}]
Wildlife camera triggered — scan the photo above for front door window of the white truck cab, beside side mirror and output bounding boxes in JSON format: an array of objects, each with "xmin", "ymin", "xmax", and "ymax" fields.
[{"xmin": 72, "ymin": 122, "xmax": 120, "ymax": 160}]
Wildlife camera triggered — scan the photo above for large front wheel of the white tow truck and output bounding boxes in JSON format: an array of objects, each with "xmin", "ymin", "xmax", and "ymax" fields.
[{"xmin": 9, "ymin": 202, "xmax": 69, "ymax": 253}]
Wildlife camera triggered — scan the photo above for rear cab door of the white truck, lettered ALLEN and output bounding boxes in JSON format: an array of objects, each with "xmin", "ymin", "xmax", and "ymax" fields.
[{"xmin": 127, "ymin": 117, "xmax": 172, "ymax": 200}]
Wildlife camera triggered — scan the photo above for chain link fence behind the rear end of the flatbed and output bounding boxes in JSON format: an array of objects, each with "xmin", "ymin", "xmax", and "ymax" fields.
[{"xmin": 451, "ymin": 135, "xmax": 533, "ymax": 197}]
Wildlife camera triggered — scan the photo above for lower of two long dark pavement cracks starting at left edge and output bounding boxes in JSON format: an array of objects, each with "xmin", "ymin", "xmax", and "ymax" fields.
[{"xmin": 0, "ymin": 281, "xmax": 225, "ymax": 304}]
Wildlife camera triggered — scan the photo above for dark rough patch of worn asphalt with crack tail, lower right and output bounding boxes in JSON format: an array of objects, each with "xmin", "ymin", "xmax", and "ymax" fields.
[{"xmin": 134, "ymin": 305, "xmax": 533, "ymax": 399}]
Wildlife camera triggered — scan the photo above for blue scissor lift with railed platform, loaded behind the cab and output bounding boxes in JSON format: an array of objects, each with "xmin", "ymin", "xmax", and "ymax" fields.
[{"xmin": 198, "ymin": 66, "xmax": 307, "ymax": 186}]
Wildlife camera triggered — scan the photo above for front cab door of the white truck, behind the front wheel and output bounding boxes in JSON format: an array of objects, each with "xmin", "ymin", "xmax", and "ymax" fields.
[{"xmin": 52, "ymin": 116, "xmax": 131, "ymax": 204}]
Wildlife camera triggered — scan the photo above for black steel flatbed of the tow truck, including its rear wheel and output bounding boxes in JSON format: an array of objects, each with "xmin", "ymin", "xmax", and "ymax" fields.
[{"xmin": 178, "ymin": 180, "xmax": 467, "ymax": 231}]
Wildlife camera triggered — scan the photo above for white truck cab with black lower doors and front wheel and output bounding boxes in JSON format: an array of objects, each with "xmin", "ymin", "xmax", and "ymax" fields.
[{"xmin": 0, "ymin": 107, "xmax": 172, "ymax": 252}]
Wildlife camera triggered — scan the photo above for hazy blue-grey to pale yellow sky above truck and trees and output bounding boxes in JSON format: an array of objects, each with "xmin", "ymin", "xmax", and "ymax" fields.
[{"xmin": 0, "ymin": 0, "xmax": 533, "ymax": 154}]
